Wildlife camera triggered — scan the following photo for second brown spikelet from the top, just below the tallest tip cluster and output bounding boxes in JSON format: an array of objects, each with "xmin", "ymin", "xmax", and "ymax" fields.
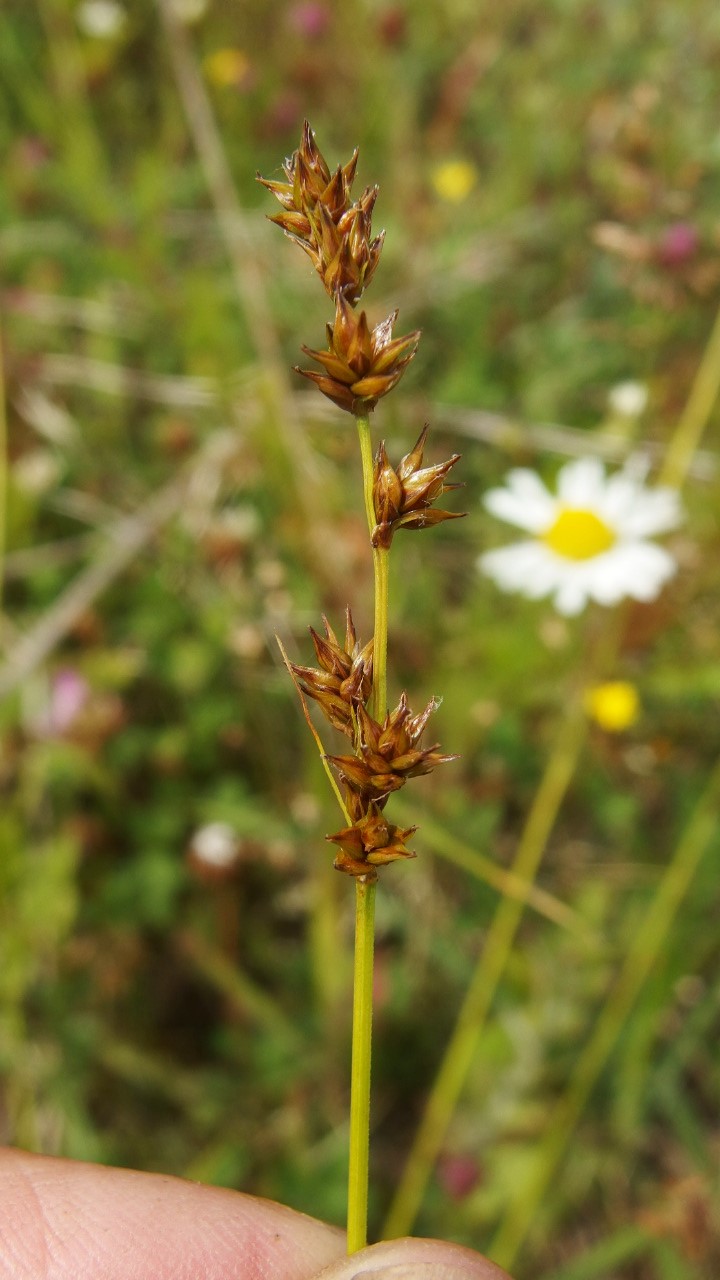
[{"xmin": 296, "ymin": 293, "xmax": 420, "ymax": 413}]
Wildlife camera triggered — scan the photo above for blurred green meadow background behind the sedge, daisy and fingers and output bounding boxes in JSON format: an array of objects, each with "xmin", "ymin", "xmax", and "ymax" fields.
[{"xmin": 0, "ymin": 0, "xmax": 720, "ymax": 1280}]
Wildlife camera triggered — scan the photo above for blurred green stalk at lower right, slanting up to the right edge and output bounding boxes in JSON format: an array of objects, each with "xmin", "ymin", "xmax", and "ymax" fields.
[{"xmin": 491, "ymin": 760, "xmax": 720, "ymax": 1267}]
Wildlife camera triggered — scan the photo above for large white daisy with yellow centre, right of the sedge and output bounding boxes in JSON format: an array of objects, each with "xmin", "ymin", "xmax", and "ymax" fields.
[{"xmin": 478, "ymin": 458, "xmax": 682, "ymax": 616}]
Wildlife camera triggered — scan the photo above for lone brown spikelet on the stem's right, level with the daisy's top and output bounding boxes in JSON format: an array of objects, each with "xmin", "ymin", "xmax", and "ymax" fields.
[{"xmin": 373, "ymin": 425, "xmax": 465, "ymax": 549}]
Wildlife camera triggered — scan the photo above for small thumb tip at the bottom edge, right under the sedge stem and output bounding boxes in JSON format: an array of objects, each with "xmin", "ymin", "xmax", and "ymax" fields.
[{"xmin": 314, "ymin": 1239, "xmax": 511, "ymax": 1280}]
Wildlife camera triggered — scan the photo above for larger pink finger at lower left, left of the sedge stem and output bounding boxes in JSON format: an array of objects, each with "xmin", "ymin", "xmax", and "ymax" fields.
[{"xmin": 0, "ymin": 1149, "xmax": 345, "ymax": 1280}]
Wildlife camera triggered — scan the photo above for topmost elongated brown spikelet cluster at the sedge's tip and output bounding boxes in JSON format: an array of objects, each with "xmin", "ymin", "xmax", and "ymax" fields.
[{"xmin": 258, "ymin": 120, "xmax": 384, "ymax": 305}]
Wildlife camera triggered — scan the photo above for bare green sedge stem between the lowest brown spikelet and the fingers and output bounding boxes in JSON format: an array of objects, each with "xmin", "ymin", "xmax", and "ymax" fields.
[{"xmin": 347, "ymin": 878, "xmax": 375, "ymax": 1253}]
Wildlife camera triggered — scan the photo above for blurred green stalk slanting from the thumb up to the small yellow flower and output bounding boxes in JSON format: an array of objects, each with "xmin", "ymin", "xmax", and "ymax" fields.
[{"xmin": 383, "ymin": 694, "xmax": 587, "ymax": 1239}]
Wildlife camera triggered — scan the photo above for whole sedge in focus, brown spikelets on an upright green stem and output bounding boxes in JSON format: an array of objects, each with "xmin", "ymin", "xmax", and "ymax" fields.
[{"xmin": 259, "ymin": 122, "xmax": 460, "ymax": 1253}]
